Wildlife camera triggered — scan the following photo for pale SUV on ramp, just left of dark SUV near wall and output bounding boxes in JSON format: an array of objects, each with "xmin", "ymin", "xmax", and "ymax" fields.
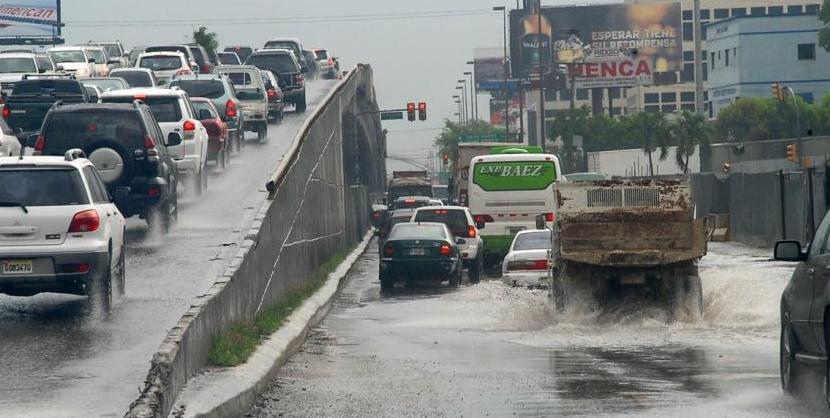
[{"xmin": 216, "ymin": 65, "xmax": 268, "ymax": 143}]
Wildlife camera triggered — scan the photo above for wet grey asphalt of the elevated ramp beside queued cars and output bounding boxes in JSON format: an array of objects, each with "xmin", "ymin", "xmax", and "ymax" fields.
[{"xmin": 0, "ymin": 81, "xmax": 342, "ymax": 417}]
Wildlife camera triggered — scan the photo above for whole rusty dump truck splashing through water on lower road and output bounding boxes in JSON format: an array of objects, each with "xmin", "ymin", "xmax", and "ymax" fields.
[{"xmin": 552, "ymin": 179, "xmax": 707, "ymax": 317}]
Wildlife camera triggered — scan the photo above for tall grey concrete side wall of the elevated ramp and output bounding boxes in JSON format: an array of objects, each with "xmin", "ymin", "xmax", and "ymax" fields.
[{"xmin": 126, "ymin": 65, "xmax": 383, "ymax": 417}]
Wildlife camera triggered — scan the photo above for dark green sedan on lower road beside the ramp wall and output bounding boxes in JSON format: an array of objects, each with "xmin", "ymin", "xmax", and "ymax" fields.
[{"xmin": 380, "ymin": 222, "xmax": 466, "ymax": 290}]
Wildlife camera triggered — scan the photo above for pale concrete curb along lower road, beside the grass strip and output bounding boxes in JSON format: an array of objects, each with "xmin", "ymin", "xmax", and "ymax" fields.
[{"xmin": 170, "ymin": 230, "xmax": 374, "ymax": 418}]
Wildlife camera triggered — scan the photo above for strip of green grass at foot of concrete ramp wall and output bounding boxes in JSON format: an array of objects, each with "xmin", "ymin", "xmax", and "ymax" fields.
[{"xmin": 208, "ymin": 249, "xmax": 352, "ymax": 367}]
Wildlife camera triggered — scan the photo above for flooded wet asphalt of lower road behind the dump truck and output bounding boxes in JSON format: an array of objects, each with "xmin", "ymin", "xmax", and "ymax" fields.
[{"xmin": 246, "ymin": 244, "xmax": 827, "ymax": 418}]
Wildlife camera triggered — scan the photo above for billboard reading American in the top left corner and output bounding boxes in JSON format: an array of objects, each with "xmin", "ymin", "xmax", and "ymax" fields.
[{"xmin": 0, "ymin": 0, "xmax": 61, "ymax": 44}]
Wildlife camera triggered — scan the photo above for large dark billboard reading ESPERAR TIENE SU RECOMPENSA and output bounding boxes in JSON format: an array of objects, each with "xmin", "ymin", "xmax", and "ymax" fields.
[{"xmin": 510, "ymin": 3, "xmax": 683, "ymax": 88}]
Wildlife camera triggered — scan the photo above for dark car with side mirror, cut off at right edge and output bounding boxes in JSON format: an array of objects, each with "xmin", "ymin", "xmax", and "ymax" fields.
[{"xmin": 775, "ymin": 214, "xmax": 830, "ymax": 405}]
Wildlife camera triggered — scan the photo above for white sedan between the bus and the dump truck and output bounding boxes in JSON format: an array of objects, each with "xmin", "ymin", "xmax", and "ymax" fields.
[{"xmin": 501, "ymin": 230, "xmax": 552, "ymax": 287}]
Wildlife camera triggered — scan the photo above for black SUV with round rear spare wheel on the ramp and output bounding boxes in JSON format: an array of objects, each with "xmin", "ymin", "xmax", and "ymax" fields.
[{"xmin": 30, "ymin": 101, "xmax": 182, "ymax": 231}]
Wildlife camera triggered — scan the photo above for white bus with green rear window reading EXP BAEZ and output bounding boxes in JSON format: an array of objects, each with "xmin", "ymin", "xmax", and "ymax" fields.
[{"xmin": 468, "ymin": 148, "xmax": 563, "ymax": 263}]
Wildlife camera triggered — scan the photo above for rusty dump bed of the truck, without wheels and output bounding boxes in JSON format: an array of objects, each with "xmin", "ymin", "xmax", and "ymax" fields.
[{"xmin": 557, "ymin": 180, "xmax": 707, "ymax": 267}]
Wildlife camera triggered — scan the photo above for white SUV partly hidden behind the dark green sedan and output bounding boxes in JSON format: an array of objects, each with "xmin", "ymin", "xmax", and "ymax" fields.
[{"xmin": 410, "ymin": 206, "xmax": 484, "ymax": 283}]
